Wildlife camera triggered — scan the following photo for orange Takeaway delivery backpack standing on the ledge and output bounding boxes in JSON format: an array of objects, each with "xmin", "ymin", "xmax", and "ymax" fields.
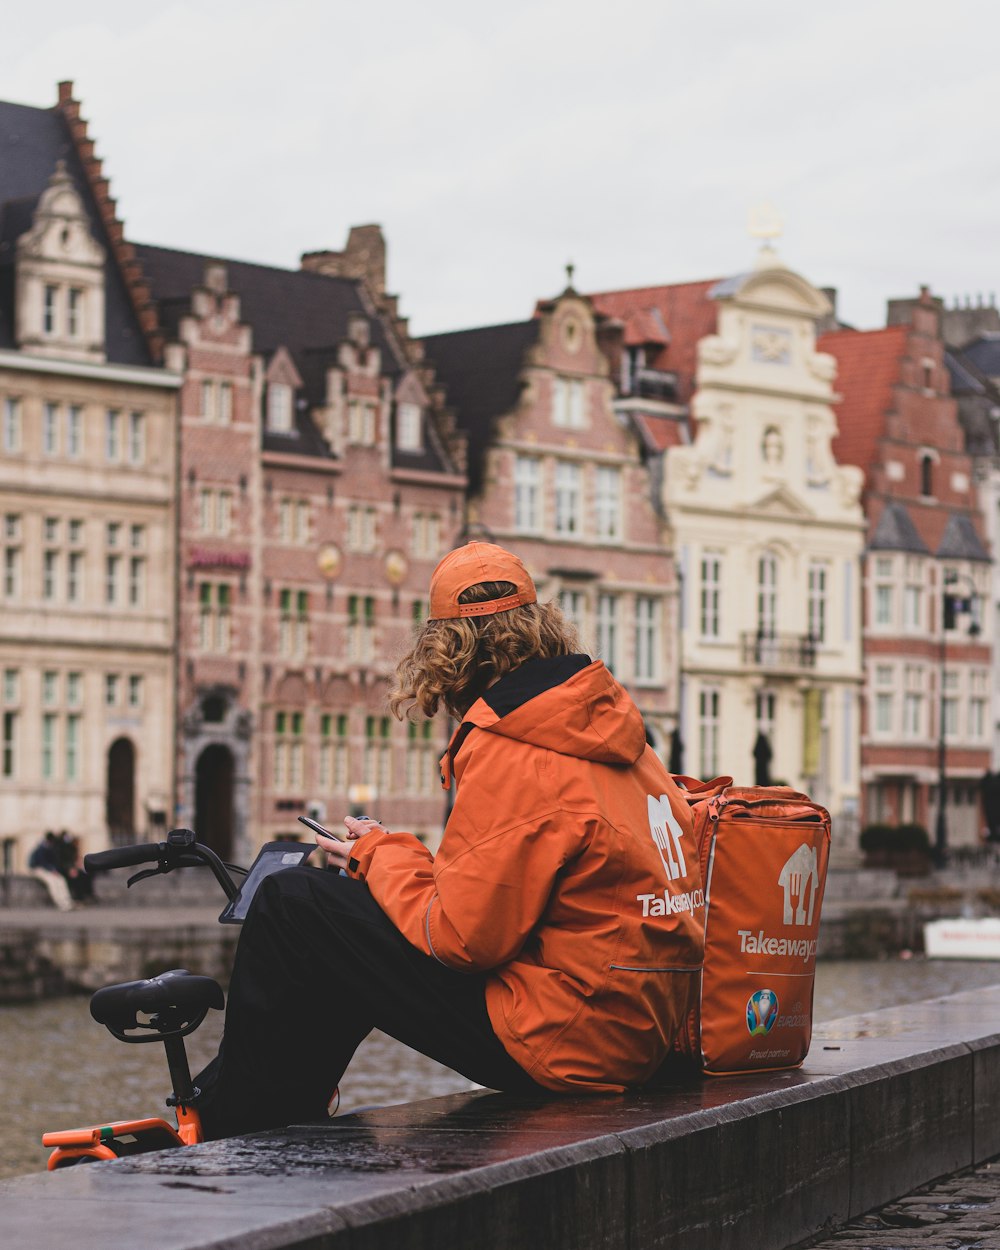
[{"xmin": 674, "ymin": 778, "xmax": 830, "ymax": 1076}]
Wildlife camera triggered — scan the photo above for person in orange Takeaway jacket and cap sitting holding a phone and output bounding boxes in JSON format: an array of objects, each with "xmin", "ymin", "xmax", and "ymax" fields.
[{"xmin": 196, "ymin": 543, "xmax": 704, "ymax": 1139}]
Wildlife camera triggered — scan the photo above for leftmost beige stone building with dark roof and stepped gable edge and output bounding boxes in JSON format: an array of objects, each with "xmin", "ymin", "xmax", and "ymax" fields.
[{"xmin": 0, "ymin": 84, "xmax": 180, "ymax": 871}]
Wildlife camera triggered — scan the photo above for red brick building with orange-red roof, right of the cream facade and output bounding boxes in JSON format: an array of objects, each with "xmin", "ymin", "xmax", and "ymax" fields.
[{"xmin": 820, "ymin": 289, "xmax": 994, "ymax": 846}]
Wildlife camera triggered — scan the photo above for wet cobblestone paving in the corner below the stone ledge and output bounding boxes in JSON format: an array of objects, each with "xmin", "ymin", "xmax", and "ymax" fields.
[{"xmin": 808, "ymin": 1159, "xmax": 1000, "ymax": 1250}]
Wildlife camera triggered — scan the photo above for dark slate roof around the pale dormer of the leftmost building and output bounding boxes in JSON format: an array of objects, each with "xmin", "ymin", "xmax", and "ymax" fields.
[{"xmin": 0, "ymin": 101, "xmax": 151, "ymax": 365}]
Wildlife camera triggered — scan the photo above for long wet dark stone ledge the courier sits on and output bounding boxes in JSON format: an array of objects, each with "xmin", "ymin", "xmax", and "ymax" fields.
[{"xmin": 0, "ymin": 986, "xmax": 1000, "ymax": 1250}]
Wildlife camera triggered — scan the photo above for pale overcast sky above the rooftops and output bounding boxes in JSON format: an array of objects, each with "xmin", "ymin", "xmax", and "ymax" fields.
[{"xmin": 7, "ymin": 0, "xmax": 1000, "ymax": 334}]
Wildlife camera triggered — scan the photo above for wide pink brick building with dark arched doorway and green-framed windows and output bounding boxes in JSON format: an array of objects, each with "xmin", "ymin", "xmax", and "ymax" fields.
[{"xmin": 136, "ymin": 228, "xmax": 465, "ymax": 858}]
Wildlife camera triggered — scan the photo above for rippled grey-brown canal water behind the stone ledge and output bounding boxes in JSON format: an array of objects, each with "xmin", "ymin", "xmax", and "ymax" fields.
[{"xmin": 0, "ymin": 958, "xmax": 1000, "ymax": 1176}]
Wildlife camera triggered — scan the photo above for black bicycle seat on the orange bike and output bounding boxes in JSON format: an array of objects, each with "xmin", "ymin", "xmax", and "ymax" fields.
[{"xmin": 90, "ymin": 968, "xmax": 225, "ymax": 1041}]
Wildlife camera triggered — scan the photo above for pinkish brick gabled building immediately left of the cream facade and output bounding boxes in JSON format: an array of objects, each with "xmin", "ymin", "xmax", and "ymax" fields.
[{"xmin": 424, "ymin": 285, "xmax": 678, "ymax": 758}]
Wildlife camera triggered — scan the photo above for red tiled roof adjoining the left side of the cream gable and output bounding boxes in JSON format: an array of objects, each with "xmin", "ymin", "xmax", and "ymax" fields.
[{"xmin": 589, "ymin": 278, "xmax": 720, "ymax": 403}]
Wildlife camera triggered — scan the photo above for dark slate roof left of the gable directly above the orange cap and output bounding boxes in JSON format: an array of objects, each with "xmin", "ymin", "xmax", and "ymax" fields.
[{"xmin": 423, "ymin": 318, "xmax": 540, "ymax": 491}]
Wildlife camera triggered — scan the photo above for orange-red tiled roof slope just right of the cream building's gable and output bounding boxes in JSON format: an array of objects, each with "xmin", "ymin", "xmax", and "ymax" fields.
[{"xmin": 816, "ymin": 325, "xmax": 910, "ymax": 470}]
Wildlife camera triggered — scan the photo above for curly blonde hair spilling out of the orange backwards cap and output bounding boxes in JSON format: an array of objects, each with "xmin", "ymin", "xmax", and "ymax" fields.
[{"xmin": 389, "ymin": 581, "xmax": 580, "ymax": 720}]
